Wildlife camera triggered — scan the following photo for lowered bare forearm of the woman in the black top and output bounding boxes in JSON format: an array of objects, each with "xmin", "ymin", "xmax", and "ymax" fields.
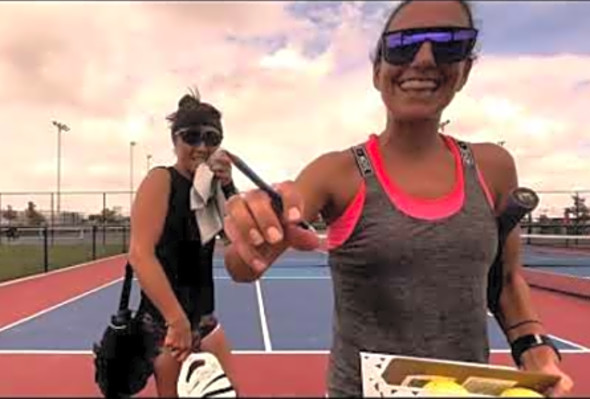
[{"xmin": 129, "ymin": 253, "xmax": 185, "ymax": 324}]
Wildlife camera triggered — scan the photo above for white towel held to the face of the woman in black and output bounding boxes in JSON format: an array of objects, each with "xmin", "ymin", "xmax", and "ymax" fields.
[{"xmin": 190, "ymin": 163, "xmax": 225, "ymax": 244}]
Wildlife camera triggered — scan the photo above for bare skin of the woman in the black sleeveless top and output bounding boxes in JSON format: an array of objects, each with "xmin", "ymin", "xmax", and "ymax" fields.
[{"xmin": 129, "ymin": 129, "xmax": 235, "ymax": 397}]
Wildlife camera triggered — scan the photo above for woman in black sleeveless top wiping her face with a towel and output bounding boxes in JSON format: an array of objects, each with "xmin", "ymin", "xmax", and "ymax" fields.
[{"xmin": 129, "ymin": 91, "xmax": 236, "ymax": 397}]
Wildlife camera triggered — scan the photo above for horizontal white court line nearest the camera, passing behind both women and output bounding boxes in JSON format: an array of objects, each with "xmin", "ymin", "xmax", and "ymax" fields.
[{"xmin": 0, "ymin": 349, "xmax": 590, "ymax": 356}]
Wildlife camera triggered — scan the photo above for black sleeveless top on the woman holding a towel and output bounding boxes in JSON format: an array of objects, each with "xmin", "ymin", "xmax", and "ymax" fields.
[{"xmin": 139, "ymin": 167, "xmax": 215, "ymax": 323}]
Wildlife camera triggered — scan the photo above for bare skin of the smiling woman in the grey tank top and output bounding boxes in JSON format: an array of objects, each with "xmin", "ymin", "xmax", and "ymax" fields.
[{"xmin": 225, "ymin": 1, "xmax": 573, "ymax": 396}]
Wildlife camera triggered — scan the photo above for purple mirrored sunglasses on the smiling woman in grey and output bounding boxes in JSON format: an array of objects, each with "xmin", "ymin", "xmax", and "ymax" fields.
[{"xmin": 381, "ymin": 27, "xmax": 478, "ymax": 65}]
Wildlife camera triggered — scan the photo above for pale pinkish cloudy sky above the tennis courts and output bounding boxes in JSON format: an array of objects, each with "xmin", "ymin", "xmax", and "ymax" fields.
[{"xmin": 0, "ymin": 1, "xmax": 590, "ymax": 219}]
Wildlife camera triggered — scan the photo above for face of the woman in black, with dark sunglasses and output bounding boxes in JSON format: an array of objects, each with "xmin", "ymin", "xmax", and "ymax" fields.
[{"xmin": 174, "ymin": 129, "xmax": 221, "ymax": 174}]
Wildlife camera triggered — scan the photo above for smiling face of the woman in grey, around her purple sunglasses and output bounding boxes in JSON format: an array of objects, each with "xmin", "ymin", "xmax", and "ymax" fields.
[{"xmin": 373, "ymin": 0, "xmax": 472, "ymax": 120}]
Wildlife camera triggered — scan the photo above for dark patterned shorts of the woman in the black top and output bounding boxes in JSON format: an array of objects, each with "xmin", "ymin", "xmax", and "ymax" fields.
[{"xmin": 138, "ymin": 312, "xmax": 219, "ymax": 356}]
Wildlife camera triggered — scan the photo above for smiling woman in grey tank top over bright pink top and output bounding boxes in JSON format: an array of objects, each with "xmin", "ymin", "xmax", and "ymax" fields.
[{"xmin": 225, "ymin": 0, "xmax": 572, "ymax": 396}]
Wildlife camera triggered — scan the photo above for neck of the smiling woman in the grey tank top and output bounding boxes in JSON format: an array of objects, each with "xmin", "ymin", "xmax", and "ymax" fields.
[{"xmin": 381, "ymin": 117, "xmax": 443, "ymax": 158}]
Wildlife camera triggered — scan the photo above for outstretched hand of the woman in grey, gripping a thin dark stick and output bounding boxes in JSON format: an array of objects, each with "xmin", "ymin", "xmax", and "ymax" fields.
[{"xmin": 224, "ymin": 182, "xmax": 320, "ymax": 275}]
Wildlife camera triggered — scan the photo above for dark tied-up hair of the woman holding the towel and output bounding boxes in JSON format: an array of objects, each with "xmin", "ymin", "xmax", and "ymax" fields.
[{"xmin": 166, "ymin": 86, "xmax": 223, "ymax": 135}]
